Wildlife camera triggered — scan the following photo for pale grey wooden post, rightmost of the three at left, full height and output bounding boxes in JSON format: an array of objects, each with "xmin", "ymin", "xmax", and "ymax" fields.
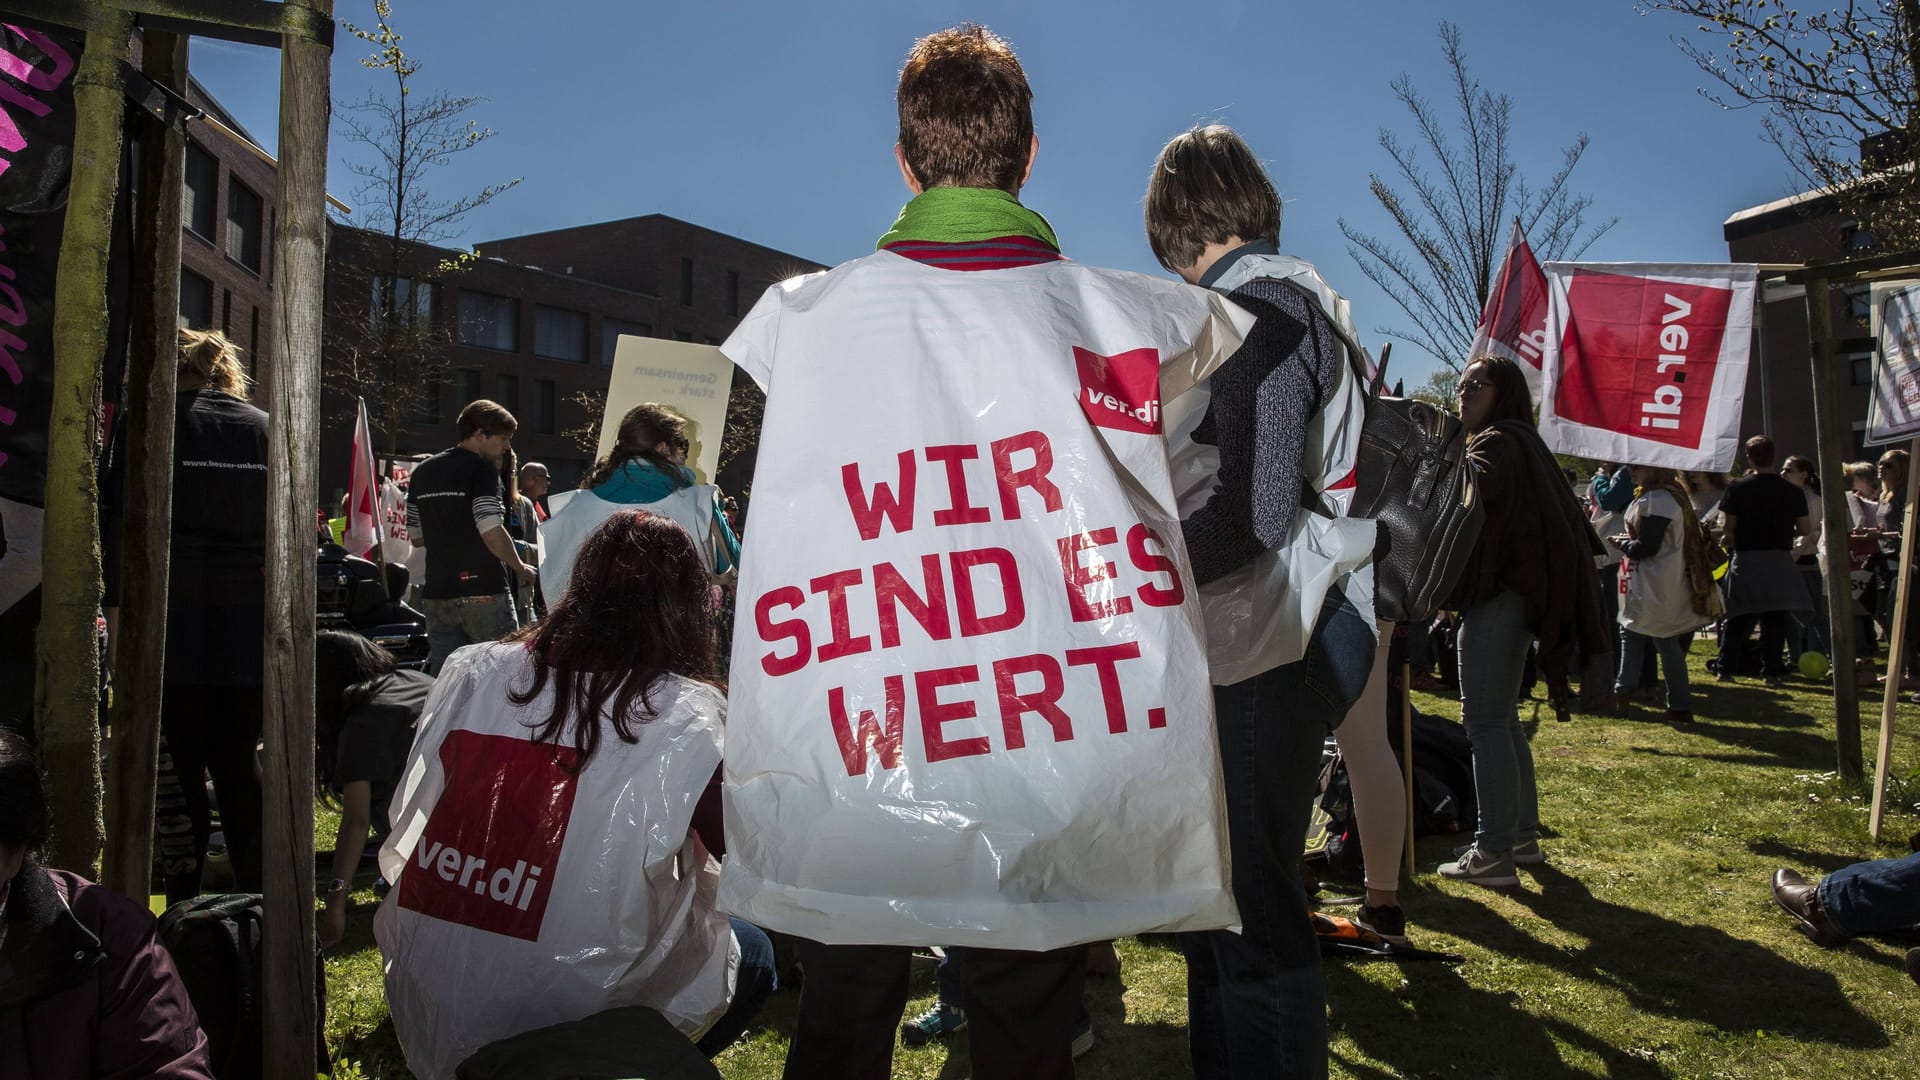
[{"xmin": 261, "ymin": 0, "xmax": 334, "ymax": 1080}]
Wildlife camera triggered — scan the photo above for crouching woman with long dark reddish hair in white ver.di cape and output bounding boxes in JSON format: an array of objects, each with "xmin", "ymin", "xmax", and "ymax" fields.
[{"xmin": 374, "ymin": 509, "xmax": 774, "ymax": 1080}]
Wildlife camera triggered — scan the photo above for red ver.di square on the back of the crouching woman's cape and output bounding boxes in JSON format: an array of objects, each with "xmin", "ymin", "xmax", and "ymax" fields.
[{"xmin": 387, "ymin": 730, "xmax": 576, "ymax": 942}]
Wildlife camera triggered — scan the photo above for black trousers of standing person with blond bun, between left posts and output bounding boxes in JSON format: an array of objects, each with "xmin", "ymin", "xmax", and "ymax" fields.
[{"xmin": 159, "ymin": 682, "xmax": 263, "ymax": 905}]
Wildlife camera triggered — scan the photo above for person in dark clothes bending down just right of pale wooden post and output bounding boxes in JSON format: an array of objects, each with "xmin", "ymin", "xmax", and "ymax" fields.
[{"xmin": 313, "ymin": 630, "xmax": 434, "ymax": 947}]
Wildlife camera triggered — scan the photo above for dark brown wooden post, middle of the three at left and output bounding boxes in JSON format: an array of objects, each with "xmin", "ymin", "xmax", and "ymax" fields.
[{"xmin": 102, "ymin": 31, "xmax": 186, "ymax": 905}]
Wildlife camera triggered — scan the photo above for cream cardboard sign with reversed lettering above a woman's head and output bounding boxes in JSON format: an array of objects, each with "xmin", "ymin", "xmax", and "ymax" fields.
[{"xmin": 597, "ymin": 334, "xmax": 733, "ymax": 484}]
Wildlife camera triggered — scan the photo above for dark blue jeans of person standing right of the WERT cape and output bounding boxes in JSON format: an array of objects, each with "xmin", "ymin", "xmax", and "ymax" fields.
[{"xmin": 1179, "ymin": 590, "xmax": 1375, "ymax": 1080}]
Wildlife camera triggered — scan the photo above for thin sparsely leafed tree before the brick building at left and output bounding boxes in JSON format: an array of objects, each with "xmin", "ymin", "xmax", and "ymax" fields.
[{"xmin": 324, "ymin": 0, "xmax": 520, "ymax": 454}]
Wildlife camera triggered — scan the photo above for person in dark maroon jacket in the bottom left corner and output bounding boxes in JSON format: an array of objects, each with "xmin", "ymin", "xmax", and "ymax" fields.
[{"xmin": 0, "ymin": 730, "xmax": 213, "ymax": 1080}]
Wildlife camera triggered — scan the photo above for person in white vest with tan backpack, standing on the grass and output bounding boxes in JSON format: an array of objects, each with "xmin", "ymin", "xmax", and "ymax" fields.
[{"xmin": 1607, "ymin": 465, "xmax": 1720, "ymax": 723}]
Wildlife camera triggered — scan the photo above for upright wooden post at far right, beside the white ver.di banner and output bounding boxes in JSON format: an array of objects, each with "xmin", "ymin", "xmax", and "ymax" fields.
[{"xmin": 1807, "ymin": 277, "xmax": 1860, "ymax": 778}]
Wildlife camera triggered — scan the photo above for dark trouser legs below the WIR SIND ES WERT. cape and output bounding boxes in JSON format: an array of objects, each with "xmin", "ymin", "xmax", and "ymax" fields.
[{"xmin": 785, "ymin": 940, "xmax": 1087, "ymax": 1080}]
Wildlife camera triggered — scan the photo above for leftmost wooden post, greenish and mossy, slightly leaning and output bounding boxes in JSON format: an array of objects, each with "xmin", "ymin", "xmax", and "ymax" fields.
[{"xmin": 35, "ymin": 8, "xmax": 132, "ymax": 878}]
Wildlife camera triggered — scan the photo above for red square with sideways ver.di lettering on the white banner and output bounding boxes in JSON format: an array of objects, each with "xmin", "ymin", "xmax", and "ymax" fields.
[{"xmin": 1553, "ymin": 271, "xmax": 1734, "ymax": 446}]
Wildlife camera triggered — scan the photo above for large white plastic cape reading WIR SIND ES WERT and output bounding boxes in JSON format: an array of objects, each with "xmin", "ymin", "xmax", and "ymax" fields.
[{"xmin": 720, "ymin": 252, "xmax": 1252, "ymax": 949}]
